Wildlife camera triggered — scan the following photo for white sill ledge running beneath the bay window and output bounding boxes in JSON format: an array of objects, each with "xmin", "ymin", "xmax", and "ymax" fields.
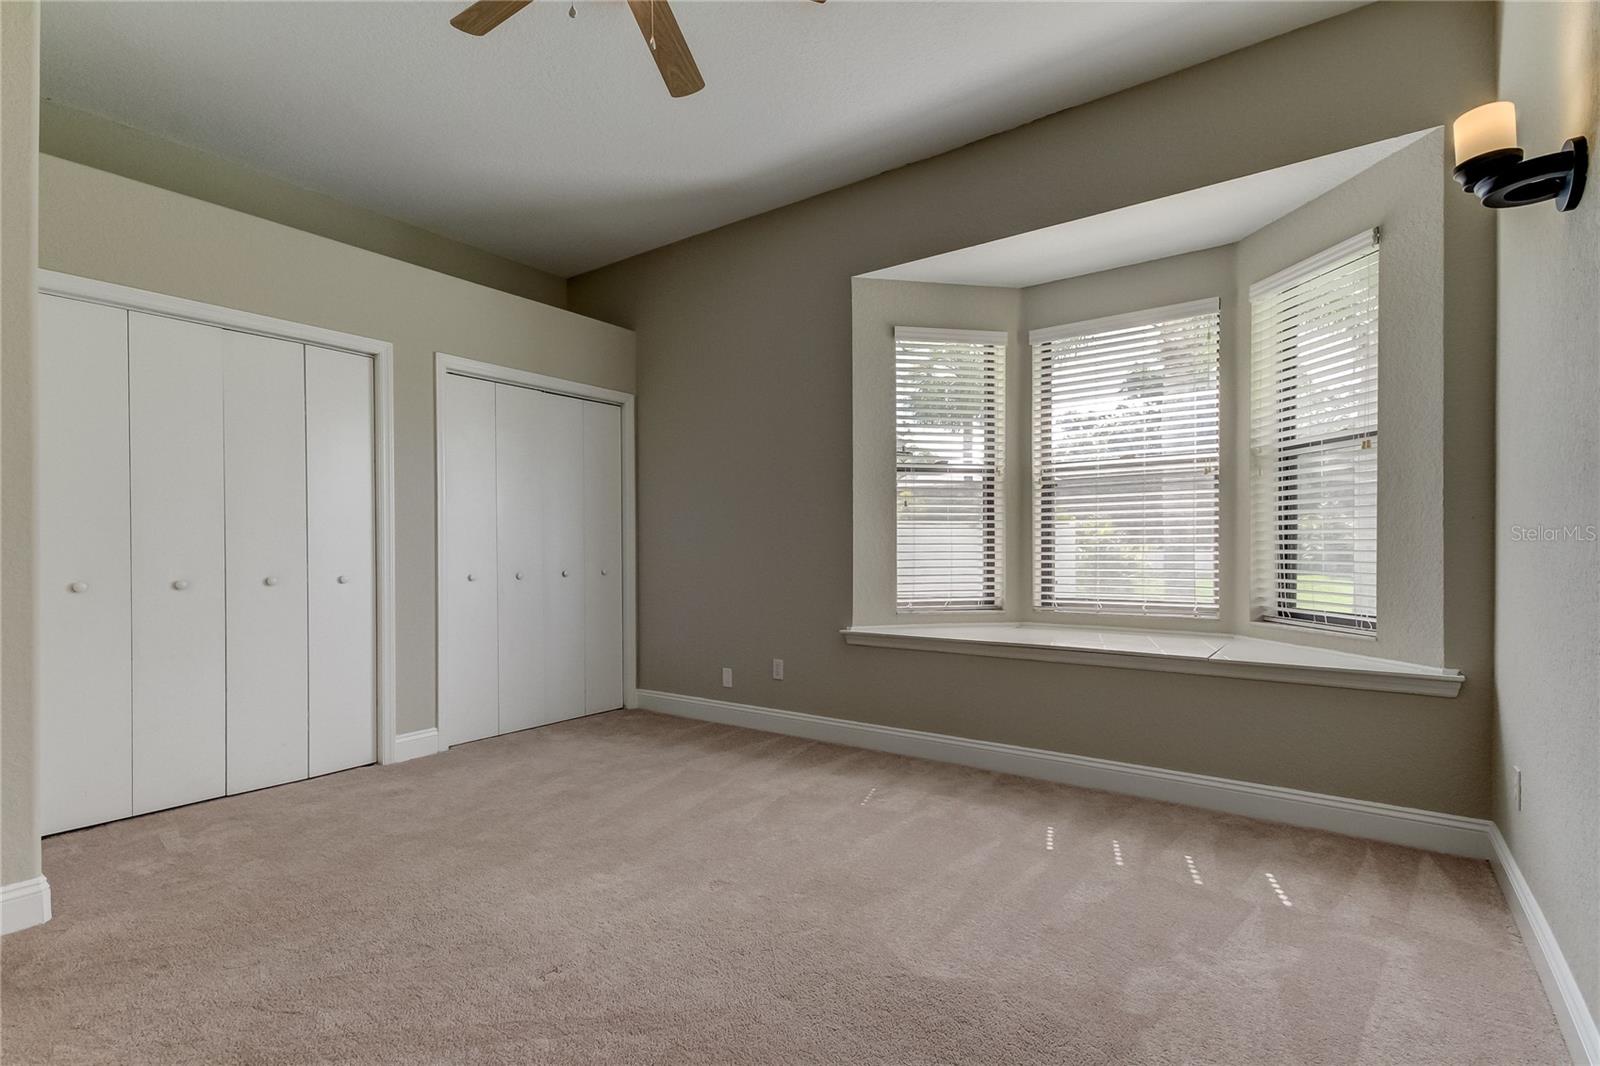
[{"xmin": 842, "ymin": 623, "xmax": 1466, "ymax": 696}]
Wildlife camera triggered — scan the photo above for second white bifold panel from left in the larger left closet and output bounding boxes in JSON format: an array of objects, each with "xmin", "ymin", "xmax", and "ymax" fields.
[{"xmin": 128, "ymin": 312, "xmax": 227, "ymax": 815}]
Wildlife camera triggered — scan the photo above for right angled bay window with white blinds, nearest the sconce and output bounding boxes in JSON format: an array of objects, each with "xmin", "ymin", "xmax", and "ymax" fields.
[{"xmin": 1250, "ymin": 230, "xmax": 1378, "ymax": 632}]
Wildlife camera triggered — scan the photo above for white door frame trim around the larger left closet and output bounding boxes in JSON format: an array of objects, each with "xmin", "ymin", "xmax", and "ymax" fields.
[{"xmin": 35, "ymin": 271, "xmax": 395, "ymax": 763}]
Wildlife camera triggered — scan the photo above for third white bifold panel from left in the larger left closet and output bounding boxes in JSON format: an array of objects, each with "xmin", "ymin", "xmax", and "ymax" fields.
[{"xmin": 222, "ymin": 331, "xmax": 307, "ymax": 794}]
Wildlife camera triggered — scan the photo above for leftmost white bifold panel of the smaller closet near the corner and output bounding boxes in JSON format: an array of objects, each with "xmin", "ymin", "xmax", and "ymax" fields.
[{"xmin": 437, "ymin": 375, "xmax": 499, "ymax": 744}]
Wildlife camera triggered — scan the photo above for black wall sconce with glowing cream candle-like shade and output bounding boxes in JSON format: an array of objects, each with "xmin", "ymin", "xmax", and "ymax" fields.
[{"xmin": 1454, "ymin": 99, "xmax": 1589, "ymax": 211}]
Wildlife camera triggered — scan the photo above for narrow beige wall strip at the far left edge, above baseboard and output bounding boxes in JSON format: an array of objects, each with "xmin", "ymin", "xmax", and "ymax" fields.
[{"xmin": 0, "ymin": 3, "xmax": 38, "ymax": 885}]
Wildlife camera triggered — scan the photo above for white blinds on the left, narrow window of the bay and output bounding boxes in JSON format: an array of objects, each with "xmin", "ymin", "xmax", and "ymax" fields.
[{"xmin": 894, "ymin": 327, "xmax": 1006, "ymax": 611}]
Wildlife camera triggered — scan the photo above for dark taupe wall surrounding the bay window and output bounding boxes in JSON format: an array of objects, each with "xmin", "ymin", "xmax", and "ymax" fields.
[{"xmin": 568, "ymin": 3, "xmax": 1494, "ymax": 815}]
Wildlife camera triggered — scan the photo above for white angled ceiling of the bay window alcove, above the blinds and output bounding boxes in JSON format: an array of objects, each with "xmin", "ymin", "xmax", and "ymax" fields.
[{"xmin": 862, "ymin": 130, "xmax": 1429, "ymax": 288}]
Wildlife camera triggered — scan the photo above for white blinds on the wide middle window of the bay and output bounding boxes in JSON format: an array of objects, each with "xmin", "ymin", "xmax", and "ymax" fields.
[{"xmin": 1030, "ymin": 299, "xmax": 1221, "ymax": 618}]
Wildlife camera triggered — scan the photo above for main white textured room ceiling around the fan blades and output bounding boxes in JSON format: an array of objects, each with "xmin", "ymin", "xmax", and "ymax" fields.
[{"xmin": 42, "ymin": 0, "xmax": 1358, "ymax": 275}]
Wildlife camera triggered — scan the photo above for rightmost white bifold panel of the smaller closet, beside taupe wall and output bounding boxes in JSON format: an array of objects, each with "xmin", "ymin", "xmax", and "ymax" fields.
[{"xmin": 584, "ymin": 403, "xmax": 622, "ymax": 712}]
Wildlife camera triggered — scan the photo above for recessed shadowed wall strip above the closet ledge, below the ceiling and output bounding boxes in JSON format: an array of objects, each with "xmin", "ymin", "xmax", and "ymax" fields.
[{"xmin": 38, "ymin": 99, "xmax": 566, "ymax": 307}]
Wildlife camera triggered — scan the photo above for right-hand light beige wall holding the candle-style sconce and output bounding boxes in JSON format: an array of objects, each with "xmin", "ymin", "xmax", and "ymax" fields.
[{"xmin": 1491, "ymin": 3, "xmax": 1600, "ymax": 1012}]
